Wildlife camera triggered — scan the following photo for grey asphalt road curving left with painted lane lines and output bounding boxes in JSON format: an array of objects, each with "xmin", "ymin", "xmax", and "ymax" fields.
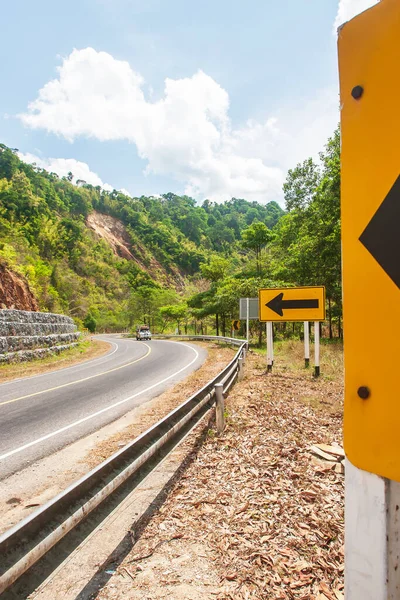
[{"xmin": 0, "ymin": 336, "xmax": 206, "ymax": 479}]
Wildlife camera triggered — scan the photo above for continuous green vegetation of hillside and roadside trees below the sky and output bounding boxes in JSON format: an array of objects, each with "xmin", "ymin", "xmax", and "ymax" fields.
[{"xmin": 0, "ymin": 130, "xmax": 342, "ymax": 343}]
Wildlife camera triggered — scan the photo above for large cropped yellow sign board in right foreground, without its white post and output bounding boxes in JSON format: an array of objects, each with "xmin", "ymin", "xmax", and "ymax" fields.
[{"xmin": 339, "ymin": 0, "xmax": 400, "ymax": 481}]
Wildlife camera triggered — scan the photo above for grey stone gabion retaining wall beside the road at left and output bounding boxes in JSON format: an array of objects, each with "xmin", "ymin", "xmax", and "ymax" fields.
[{"xmin": 0, "ymin": 309, "xmax": 80, "ymax": 363}]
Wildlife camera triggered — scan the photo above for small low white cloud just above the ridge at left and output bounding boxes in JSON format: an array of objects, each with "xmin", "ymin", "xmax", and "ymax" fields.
[{"xmin": 18, "ymin": 152, "xmax": 113, "ymax": 192}]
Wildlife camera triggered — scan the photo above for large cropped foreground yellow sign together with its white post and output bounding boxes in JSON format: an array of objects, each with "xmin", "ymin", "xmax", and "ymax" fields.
[{"xmin": 339, "ymin": 0, "xmax": 400, "ymax": 600}]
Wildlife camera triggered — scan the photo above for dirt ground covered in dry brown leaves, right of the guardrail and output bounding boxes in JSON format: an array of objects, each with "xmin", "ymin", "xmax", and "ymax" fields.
[{"xmin": 96, "ymin": 342, "xmax": 344, "ymax": 600}]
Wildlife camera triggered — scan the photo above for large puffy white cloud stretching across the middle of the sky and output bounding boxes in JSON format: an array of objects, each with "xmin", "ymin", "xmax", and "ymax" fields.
[{"xmin": 19, "ymin": 48, "xmax": 338, "ymax": 202}]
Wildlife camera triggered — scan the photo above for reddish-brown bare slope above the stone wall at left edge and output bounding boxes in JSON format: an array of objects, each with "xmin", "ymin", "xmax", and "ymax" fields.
[{"xmin": 0, "ymin": 262, "xmax": 39, "ymax": 311}]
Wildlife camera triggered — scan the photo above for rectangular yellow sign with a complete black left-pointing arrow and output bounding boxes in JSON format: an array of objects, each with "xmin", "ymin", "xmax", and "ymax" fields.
[{"xmin": 259, "ymin": 286, "xmax": 325, "ymax": 321}]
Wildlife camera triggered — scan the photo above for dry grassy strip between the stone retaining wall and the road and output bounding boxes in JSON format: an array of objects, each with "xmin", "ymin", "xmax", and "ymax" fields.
[{"xmin": 0, "ymin": 338, "xmax": 111, "ymax": 383}]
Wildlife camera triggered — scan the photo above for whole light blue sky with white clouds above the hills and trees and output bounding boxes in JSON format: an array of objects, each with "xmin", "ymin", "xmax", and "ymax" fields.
[{"xmin": 0, "ymin": 0, "xmax": 374, "ymax": 202}]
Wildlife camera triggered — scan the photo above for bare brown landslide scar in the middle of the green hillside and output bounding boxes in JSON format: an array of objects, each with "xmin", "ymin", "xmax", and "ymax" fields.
[{"xmin": 87, "ymin": 211, "xmax": 183, "ymax": 288}]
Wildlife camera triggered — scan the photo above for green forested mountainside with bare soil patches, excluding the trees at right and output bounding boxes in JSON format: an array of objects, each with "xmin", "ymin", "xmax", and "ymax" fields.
[{"xmin": 0, "ymin": 144, "xmax": 283, "ymax": 328}]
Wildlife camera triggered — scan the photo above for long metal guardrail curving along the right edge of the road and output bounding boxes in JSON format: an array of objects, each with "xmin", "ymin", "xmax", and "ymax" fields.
[{"xmin": 0, "ymin": 336, "xmax": 247, "ymax": 594}]
